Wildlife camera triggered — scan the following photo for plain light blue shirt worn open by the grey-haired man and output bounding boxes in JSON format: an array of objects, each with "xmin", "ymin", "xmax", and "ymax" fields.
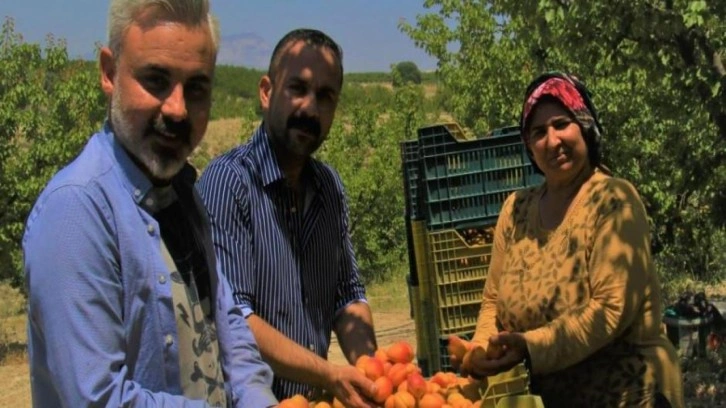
[{"xmin": 23, "ymin": 127, "xmax": 276, "ymax": 407}]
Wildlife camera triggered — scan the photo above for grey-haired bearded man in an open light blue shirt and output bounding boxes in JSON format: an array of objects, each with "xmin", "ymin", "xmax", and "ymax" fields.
[{"xmin": 23, "ymin": 0, "xmax": 277, "ymax": 407}]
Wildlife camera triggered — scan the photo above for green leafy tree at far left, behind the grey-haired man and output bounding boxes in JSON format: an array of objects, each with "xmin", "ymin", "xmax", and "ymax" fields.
[{"xmin": 0, "ymin": 19, "xmax": 105, "ymax": 287}]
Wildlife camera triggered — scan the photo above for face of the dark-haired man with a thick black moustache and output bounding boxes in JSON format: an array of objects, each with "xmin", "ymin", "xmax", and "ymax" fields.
[{"xmin": 260, "ymin": 41, "xmax": 342, "ymax": 159}]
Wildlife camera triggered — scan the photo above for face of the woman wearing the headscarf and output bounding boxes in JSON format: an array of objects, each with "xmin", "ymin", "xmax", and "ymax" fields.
[{"xmin": 527, "ymin": 100, "xmax": 590, "ymax": 181}]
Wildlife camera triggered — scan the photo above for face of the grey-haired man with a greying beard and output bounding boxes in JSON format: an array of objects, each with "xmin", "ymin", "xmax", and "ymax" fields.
[{"xmin": 101, "ymin": 13, "xmax": 216, "ymax": 184}]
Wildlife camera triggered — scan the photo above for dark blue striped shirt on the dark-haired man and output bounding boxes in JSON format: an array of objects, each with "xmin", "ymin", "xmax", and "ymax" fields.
[{"xmin": 197, "ymin": 125, "xmax": 365, "ymax": 398}]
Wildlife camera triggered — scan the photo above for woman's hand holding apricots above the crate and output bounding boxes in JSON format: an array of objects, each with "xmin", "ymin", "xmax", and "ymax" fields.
[{"xmin": 461, "ymin": 332, "xmax": 527, "ymax": 379}]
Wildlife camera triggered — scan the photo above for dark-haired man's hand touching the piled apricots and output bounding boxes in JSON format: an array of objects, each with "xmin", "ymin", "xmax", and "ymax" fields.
[{"xmin": 326, "ymin": 365, "xmax": 376, "ymax": 408}]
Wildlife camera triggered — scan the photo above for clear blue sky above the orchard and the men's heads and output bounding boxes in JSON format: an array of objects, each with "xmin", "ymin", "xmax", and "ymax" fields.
[{"xmin": 0, "ymin": 0, "xmax": 436, "ymax": 72}]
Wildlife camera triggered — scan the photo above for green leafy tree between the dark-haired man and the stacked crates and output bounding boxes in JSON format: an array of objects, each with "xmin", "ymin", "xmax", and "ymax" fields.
[{"xmin": 318, "ymin": 84, "xmax": 427, "ymax": 282}]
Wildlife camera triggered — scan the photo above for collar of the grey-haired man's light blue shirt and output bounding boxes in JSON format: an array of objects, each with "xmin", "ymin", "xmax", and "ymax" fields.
[{"xmin": 101, "ymin": 121, "xmax": 196, "ymax": 212}]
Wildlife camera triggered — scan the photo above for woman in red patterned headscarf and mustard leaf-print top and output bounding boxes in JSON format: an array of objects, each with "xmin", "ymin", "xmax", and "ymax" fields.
[{"xmin": 462, "ymin": 73, "xmax": 683, "ymax": 407}]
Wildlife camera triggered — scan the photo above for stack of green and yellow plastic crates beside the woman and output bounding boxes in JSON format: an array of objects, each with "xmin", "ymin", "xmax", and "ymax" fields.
[{"xmin": 401, "ymin": 123, "xmax": 542, "ymax": 375}]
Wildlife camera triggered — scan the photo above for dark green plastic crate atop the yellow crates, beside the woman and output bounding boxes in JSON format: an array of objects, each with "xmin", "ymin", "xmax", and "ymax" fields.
[{"xmin": 418, "ymin": 123, "xmax": 543, "ymax": 231}]
